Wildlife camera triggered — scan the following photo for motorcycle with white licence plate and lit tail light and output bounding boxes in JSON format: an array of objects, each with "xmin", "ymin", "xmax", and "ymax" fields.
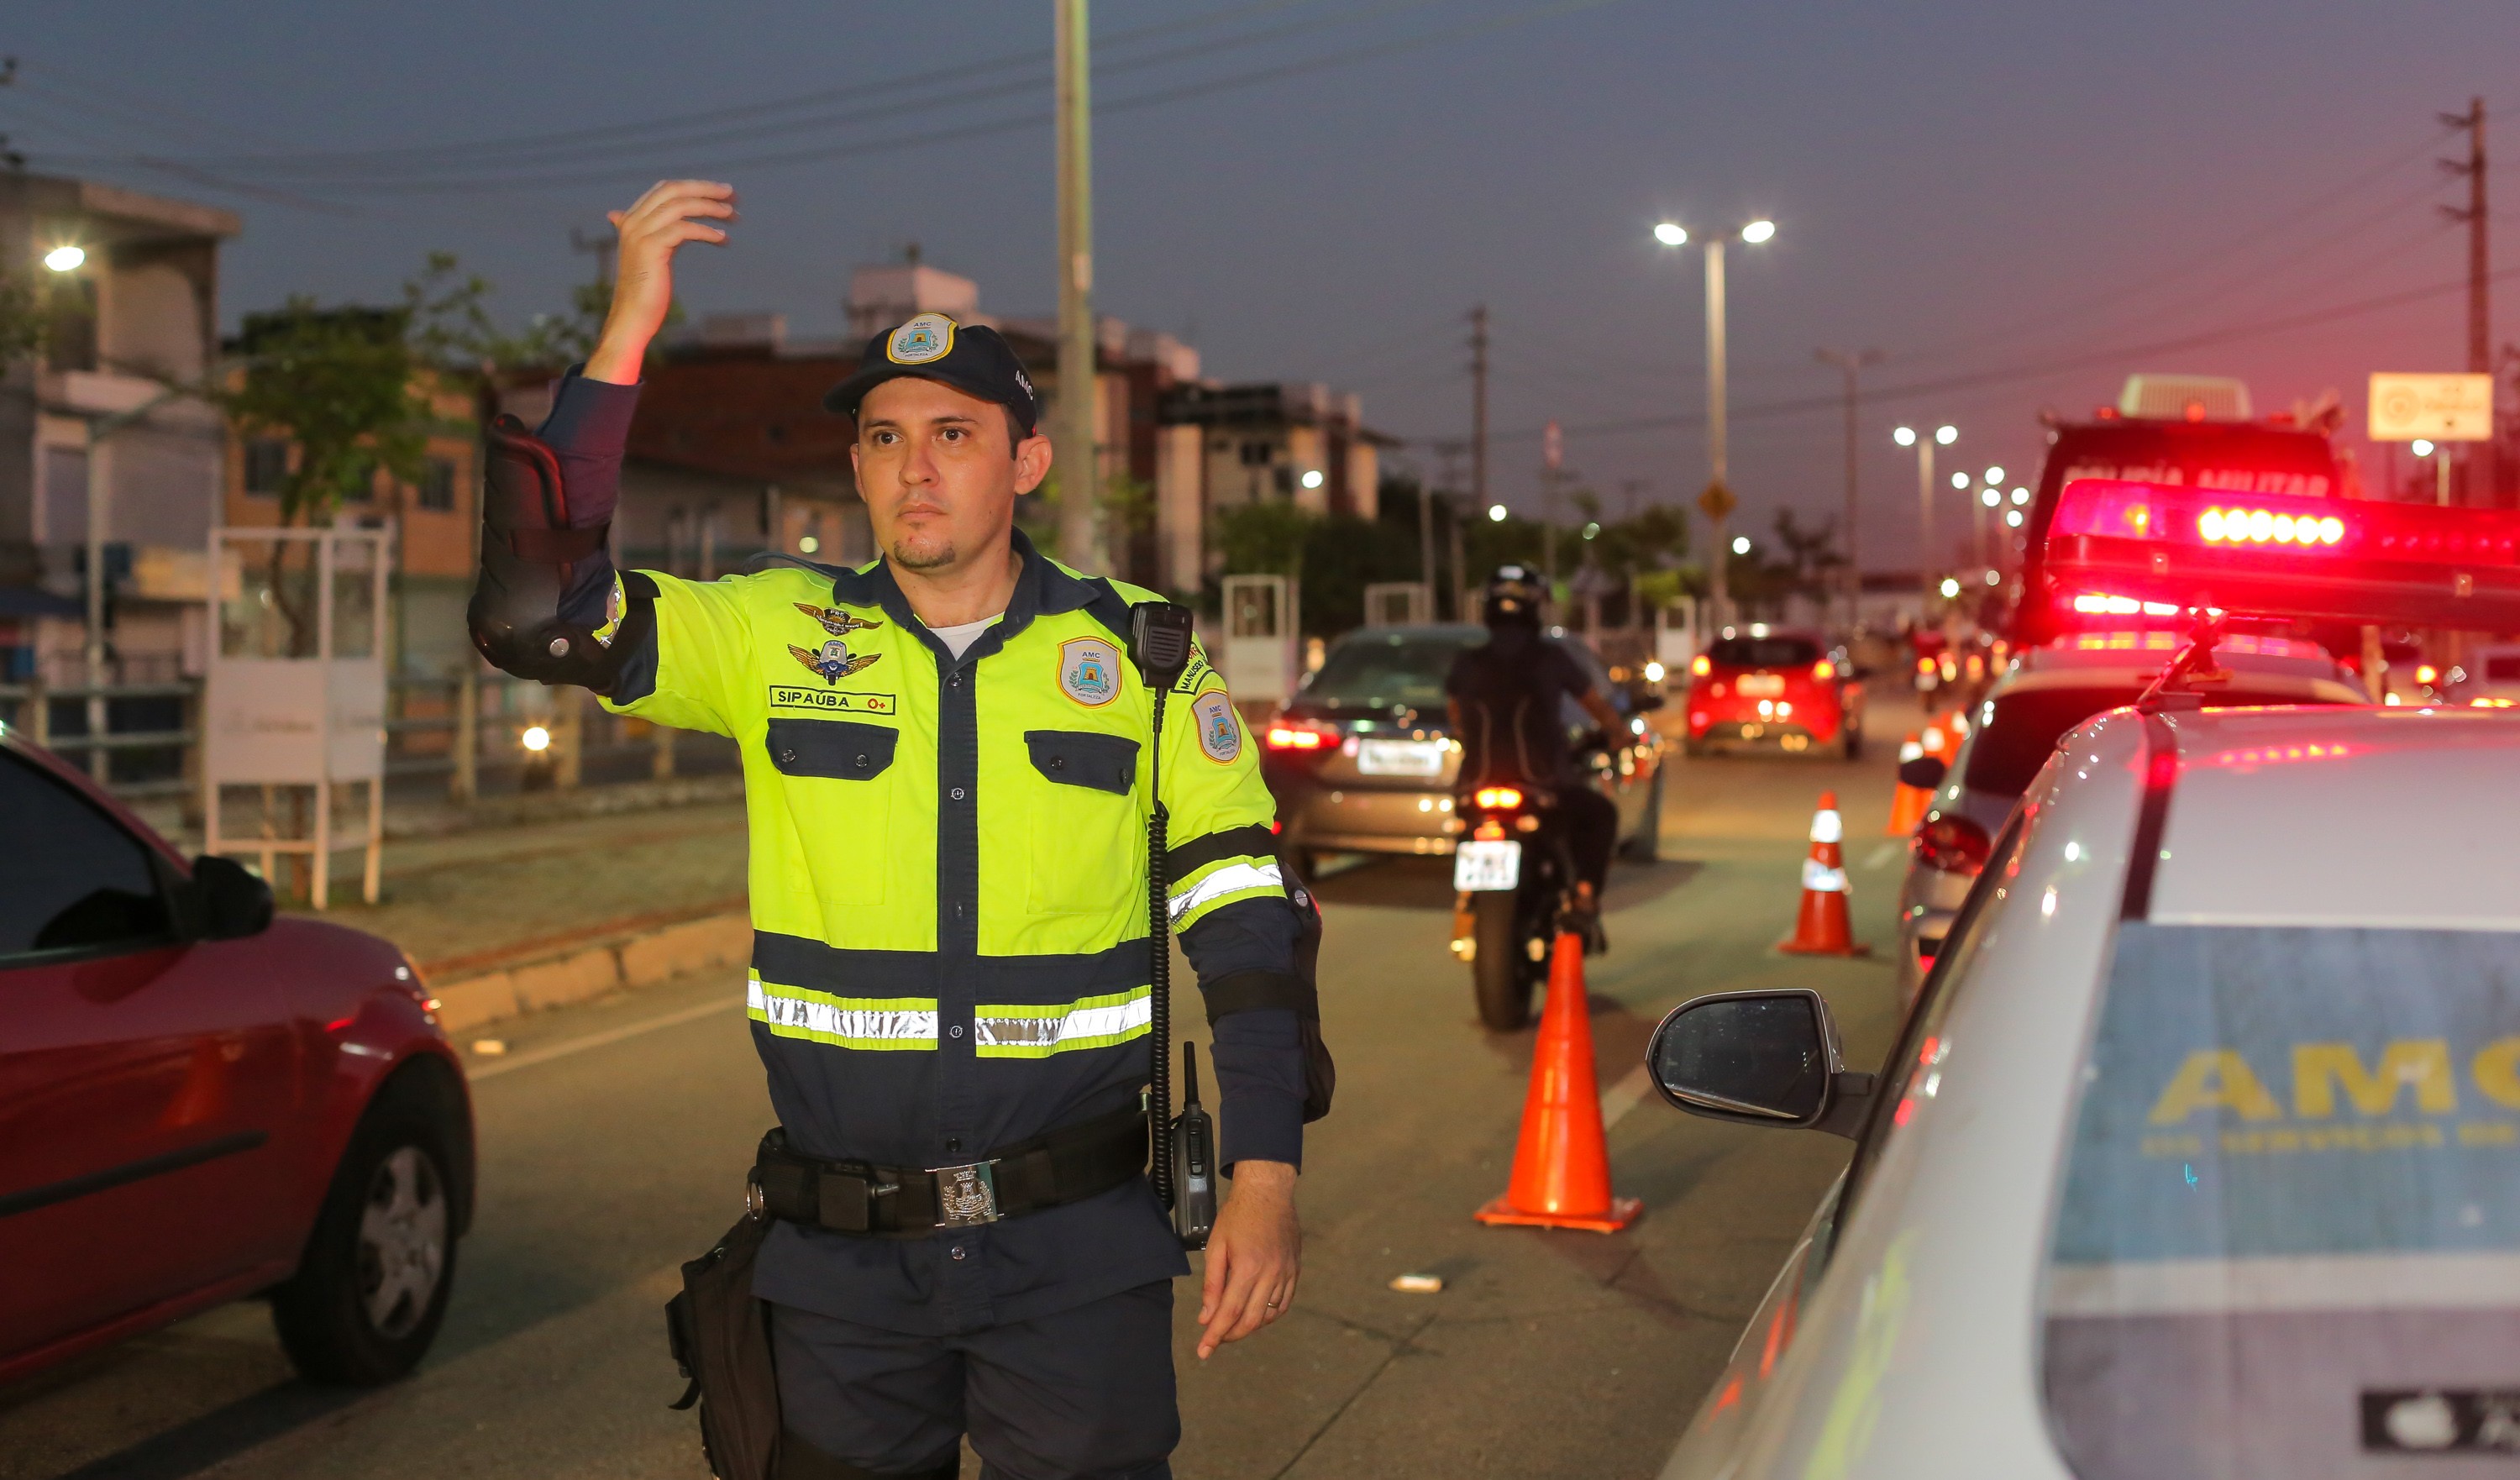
[{"xmin": 1452, "ymin": 782, "xmax": 1575, "ymax": 1034}]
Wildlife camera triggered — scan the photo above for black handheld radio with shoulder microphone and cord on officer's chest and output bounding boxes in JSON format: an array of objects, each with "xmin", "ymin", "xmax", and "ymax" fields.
[{"xmin": 1129, "ymin": 600, "xmax": 1217, "ymax": 1248}]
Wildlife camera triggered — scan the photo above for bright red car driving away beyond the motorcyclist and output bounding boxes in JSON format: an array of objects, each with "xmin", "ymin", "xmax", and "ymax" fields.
[{"xmin": 1686, "ymin": 625, "xmax": 1865, "ymax": 759}]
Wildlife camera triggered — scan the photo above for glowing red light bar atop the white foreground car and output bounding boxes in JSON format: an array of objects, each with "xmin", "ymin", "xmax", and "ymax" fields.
[{"xmin": 2046, "ymin": 479, "xmax": 2520, "ymax": 630}]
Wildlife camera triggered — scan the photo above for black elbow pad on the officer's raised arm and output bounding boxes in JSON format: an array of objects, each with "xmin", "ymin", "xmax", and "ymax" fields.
[{"xmin": 464, "ymin": 416, "xmax": 625, "ymax": 693}]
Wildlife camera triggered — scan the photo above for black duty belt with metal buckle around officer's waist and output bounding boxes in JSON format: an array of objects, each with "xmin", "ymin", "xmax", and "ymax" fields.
[{"xmin": 751, "ymin": 1105, "xmax": 1147, "ymax": 1238}]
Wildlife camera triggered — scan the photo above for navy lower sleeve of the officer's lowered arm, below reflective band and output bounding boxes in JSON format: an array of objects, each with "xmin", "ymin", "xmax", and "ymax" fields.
[{"xmin": 1179, "ymin": 897, "xmax": 1303, "ymax": 1168}]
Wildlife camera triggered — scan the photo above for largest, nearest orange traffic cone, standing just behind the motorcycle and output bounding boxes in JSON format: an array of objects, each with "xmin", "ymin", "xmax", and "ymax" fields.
[{"xmin": 1479, "ymin": 931, "xmax": 1646, "ymax": 1233}]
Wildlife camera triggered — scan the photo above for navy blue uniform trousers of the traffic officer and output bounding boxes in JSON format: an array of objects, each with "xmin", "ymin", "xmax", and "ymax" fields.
[{"xmin": 771, "ymin": 1281, "xmax": 1182, "ymax": 1480}]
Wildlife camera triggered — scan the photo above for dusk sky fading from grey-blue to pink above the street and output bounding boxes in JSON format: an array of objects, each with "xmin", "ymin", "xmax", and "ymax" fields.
[{"xmin": 0, "ymin": 0, "xmax": 2520, "ymax": 564}]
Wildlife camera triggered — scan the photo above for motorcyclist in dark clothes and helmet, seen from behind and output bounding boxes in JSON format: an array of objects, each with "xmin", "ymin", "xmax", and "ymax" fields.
[{"xmin": 1444, "ymin": 564, "xmax": 1625, "ymax": 951}]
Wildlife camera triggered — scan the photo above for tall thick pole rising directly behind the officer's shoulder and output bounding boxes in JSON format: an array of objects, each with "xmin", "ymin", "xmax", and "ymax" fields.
[{"xmin": 1051, "ymin": 0, "xmax": 1101, "ymax": 572}]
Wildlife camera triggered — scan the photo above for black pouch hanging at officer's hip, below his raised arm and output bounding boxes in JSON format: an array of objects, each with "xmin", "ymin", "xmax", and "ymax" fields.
[{"xmin": 665, "ymin": 1213, "xmax": 779, "ymax": 1480}]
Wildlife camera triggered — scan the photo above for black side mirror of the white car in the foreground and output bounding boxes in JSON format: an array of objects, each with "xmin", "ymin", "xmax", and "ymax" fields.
[{"xmin": 1646, "ymin": 989, "xmax": 1875, "ymax": 1137}]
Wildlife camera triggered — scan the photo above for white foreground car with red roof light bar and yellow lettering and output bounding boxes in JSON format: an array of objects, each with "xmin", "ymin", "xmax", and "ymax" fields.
[{"xmin": 1646, "ymin": 479, "xmax": 2520, "ymax": 1480}]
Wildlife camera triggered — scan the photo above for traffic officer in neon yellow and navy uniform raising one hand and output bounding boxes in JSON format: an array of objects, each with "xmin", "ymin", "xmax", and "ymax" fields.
[{"xmin": 471, "ymin": 181, "xmax": 1303, "ymax": 1480}]
